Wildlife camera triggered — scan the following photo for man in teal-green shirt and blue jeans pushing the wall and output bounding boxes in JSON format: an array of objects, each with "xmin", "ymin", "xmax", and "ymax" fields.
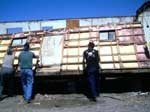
[{"xmin": 19, "ymin": 43, "xmax": 37, "ymax": 103}]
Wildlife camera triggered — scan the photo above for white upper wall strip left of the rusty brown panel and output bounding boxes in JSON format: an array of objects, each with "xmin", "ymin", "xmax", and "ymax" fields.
[{"xmin": 0, "ymin": 20, "xmax": 66, "ymax": 34}]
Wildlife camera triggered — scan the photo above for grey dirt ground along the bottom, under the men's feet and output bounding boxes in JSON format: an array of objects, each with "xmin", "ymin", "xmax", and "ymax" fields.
[{"xmin": 0, "ymin": 92, "xmax": 150, "ymax": 112}]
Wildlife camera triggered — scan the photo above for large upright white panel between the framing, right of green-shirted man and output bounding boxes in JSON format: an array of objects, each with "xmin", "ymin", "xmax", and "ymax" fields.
[{"xmin": 41, "ymin": 35, "xmax": 63, "ymax": 65}]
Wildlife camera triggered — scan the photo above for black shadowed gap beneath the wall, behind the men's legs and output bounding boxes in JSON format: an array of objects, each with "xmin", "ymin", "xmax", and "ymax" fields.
[{"xmin": 4, "ymin": 74, "xmax": 150, "ymax": 95}]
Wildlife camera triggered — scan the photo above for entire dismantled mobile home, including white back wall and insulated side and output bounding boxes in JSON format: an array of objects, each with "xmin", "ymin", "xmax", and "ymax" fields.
[{"xmin": 0, "ymin": 2, "xmax": 150, "ymax": 75}]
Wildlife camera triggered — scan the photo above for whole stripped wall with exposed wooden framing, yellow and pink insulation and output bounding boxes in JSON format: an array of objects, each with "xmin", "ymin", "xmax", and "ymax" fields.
[{"xmin": 0, "ymin": 23, "xmax": 150, "ymax": 75}]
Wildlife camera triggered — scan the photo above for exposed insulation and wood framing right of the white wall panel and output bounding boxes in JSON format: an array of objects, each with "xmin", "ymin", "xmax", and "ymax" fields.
[{"xmin": 62, "ymin": 24, "xmax": 150, "ymax": 74}]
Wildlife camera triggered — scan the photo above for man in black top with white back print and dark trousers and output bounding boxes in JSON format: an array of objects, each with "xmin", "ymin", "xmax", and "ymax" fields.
[{"xmin": 83, "ymin": 42, "xmax": 100, "ymax": 101}]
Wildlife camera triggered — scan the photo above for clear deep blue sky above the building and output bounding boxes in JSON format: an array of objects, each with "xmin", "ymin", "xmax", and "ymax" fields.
[{"xmin": 0, "ymin": 0, "xmax": 144, "ymax": 21}]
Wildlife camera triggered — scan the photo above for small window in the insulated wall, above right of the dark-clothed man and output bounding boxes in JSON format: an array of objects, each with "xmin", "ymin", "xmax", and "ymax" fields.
[{"xmin": 99, "ymin": 31, "xmax": 116, "ymax": 40}]
